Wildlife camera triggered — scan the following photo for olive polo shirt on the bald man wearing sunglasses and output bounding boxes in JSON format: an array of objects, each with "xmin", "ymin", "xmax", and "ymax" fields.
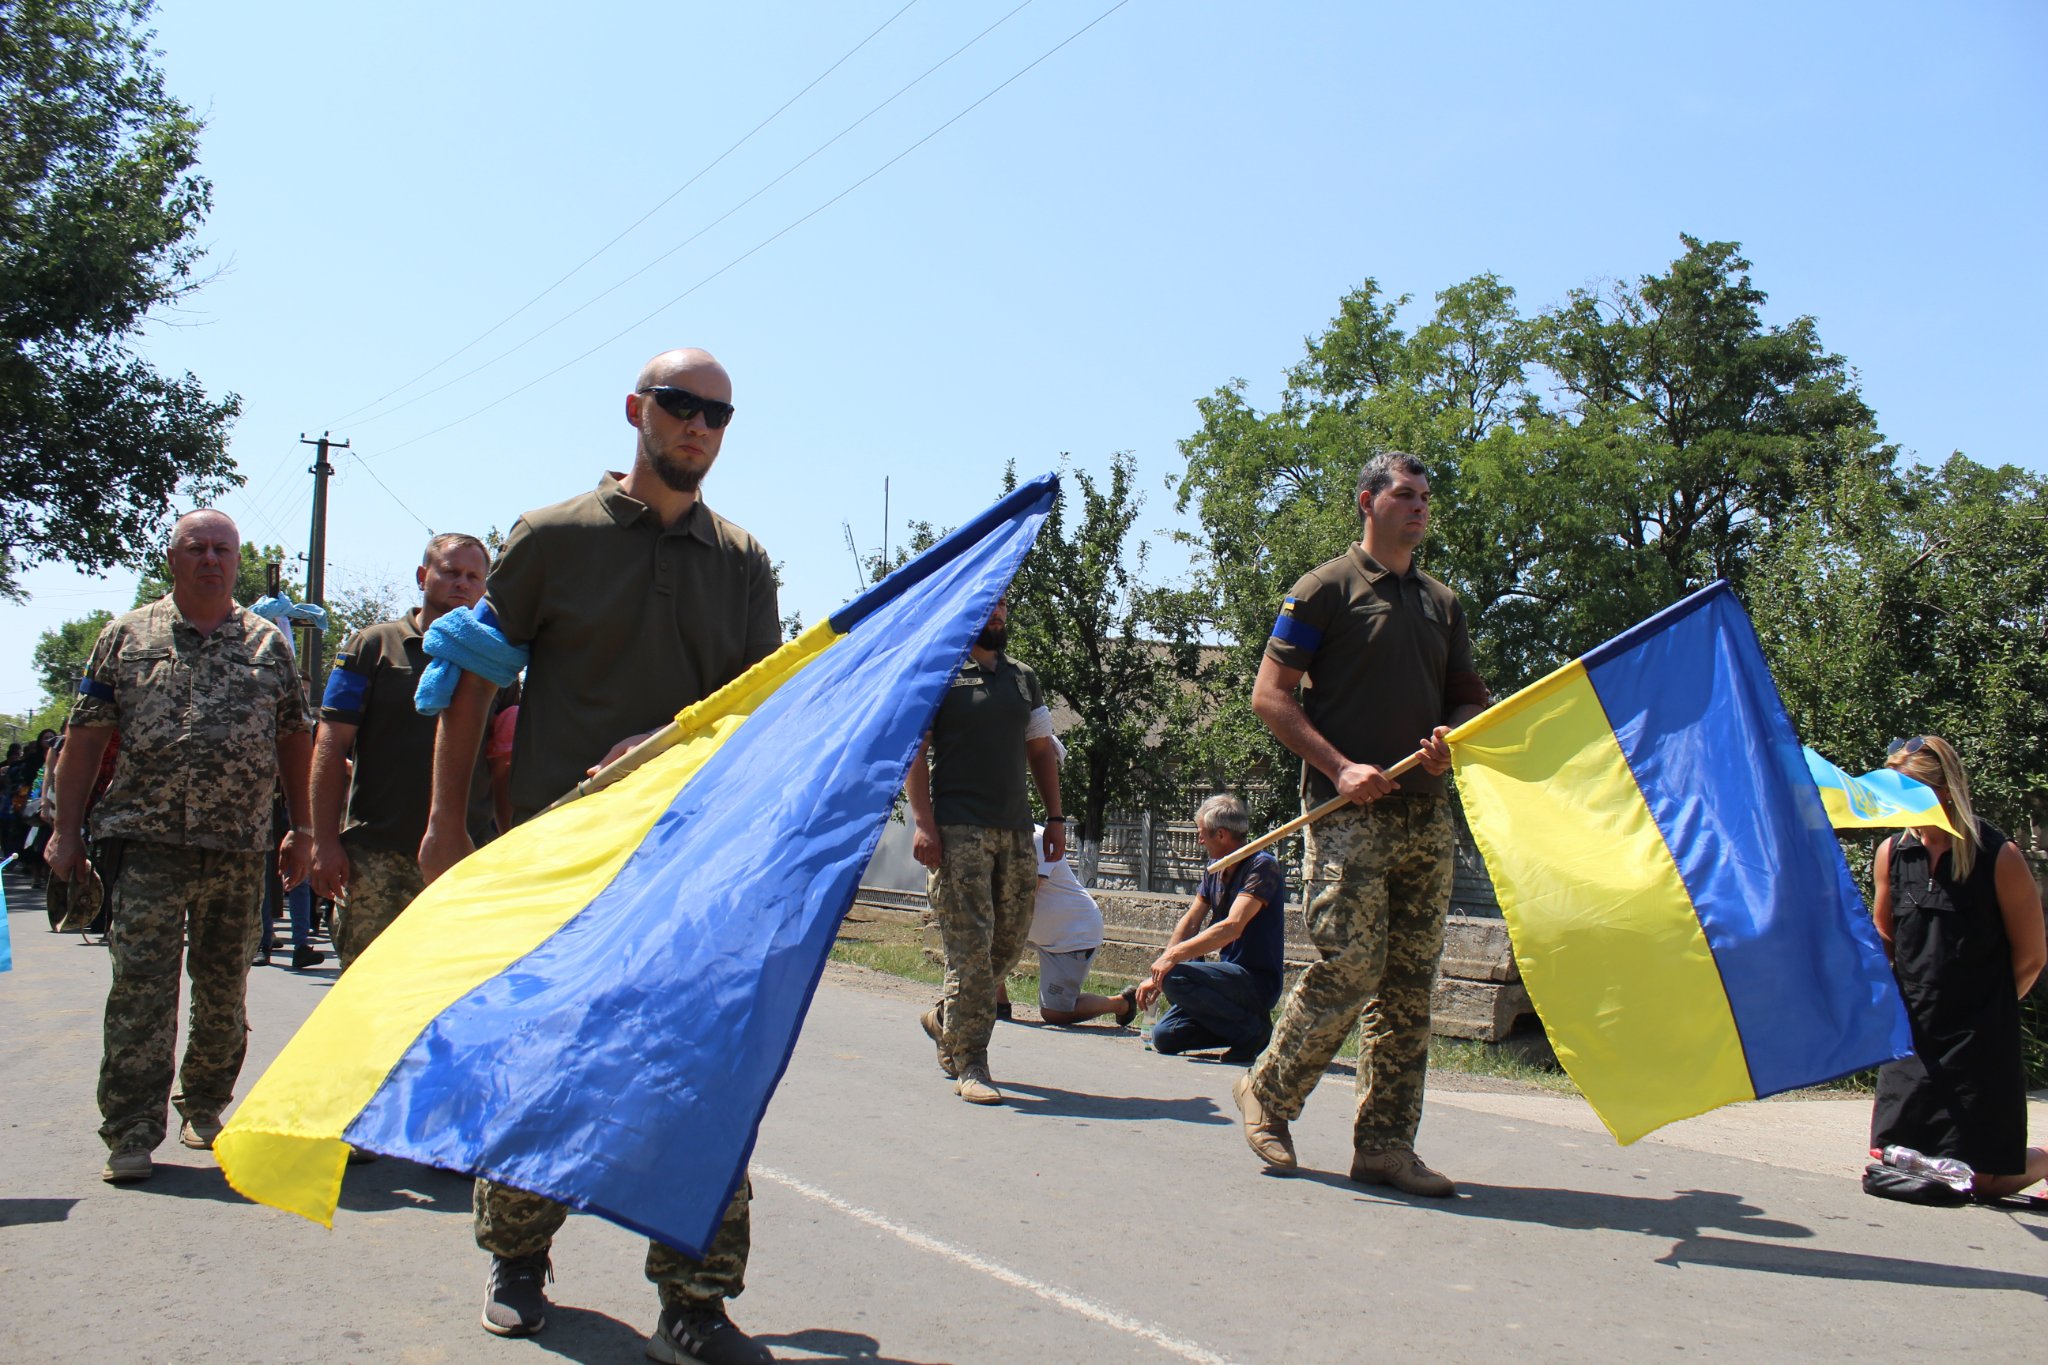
[{"xmin": 485, "ymin": 475, "xmax": 782, "ymax": 819}]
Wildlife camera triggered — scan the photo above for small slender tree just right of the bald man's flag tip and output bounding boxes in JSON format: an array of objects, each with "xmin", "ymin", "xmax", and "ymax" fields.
[{"xmin": 1004, "ymin": 452, "xmax": 1196, "ymax": 870}]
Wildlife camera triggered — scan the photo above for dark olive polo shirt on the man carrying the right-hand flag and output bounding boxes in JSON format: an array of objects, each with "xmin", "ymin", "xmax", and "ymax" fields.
[{"xmin": 1266, "ymin": 544, "xmax": 1485, "ymax": 802}]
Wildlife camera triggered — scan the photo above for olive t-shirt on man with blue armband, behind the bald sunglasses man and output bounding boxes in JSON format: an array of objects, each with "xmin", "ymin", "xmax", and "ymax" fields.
[{"xmin": 319, "ymin": 608, "xmax": 494, "ymax": 853}]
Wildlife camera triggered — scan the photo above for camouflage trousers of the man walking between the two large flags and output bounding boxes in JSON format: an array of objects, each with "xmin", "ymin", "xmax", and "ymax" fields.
[{"xmin": 926, "ymin": 825, "xmax": 1038, "ymax": 1066}]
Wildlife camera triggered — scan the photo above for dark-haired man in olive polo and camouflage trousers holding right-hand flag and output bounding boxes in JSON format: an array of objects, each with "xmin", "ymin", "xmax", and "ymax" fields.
[{"xmin": 1235, "ymin": 452, "xmax": 1491, "ymax": 1197}]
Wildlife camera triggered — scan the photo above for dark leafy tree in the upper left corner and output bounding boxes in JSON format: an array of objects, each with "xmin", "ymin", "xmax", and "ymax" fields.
[{"xmin": 0, "ymin": 0, "xmax": 240, "ymax": 593}]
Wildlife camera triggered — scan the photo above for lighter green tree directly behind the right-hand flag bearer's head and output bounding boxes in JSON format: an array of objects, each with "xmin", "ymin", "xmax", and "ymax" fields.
[{"xmin": 1176, "ymin": 274, "xmax": 1536, "ymax": 823}]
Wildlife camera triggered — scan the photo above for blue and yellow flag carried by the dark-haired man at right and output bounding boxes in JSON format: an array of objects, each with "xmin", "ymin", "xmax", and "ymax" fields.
[{"xmin": 1450, "ymin": 583, "xmax": 1913, "ymax": 1142}]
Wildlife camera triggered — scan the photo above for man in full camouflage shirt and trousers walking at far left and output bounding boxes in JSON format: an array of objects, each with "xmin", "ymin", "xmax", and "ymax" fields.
[{"xmin": 49, "ymin": 512, "xmax": 313, "ymax": 1181}]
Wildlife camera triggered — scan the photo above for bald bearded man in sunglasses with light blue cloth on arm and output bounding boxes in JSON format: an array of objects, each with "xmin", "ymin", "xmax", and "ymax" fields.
[{"xmin": 420, "ymin": 350, "xmax": 782, "ymax": 1361}]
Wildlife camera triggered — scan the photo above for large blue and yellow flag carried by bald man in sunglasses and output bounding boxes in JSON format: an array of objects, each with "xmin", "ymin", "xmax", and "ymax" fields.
[{"xmin": 213, "ymin": 475, "xmax": 1059, "ymax": 1254}]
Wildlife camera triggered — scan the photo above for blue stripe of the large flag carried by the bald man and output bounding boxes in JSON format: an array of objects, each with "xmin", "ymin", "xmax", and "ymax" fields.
[{"xmin": 346, "ymin": 477, "xmax": 1057, "ymax": 1254}]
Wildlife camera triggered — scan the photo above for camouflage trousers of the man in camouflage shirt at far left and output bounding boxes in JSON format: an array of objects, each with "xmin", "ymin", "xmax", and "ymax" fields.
[{"xmin": 100, "ymin": 839, "xmax": 262, "ymax": 1150}]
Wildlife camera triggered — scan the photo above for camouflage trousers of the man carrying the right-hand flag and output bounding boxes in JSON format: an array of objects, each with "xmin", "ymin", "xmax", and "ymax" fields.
[{"xmin": 1251, "ymin": 794, "xmax": 1456, "ymax": 1152}]
